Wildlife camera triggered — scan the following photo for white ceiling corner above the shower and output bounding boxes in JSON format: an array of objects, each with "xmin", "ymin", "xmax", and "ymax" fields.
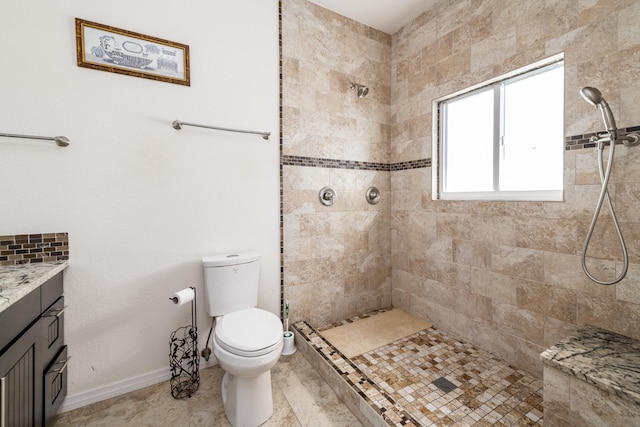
[{"xmin": 309, "ymin": 0, "xmax": 437, "ymax": 34}]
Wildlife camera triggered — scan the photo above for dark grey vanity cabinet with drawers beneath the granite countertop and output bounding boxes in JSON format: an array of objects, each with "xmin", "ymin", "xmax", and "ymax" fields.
[{"xmin": 0, "ymin": 272, "xmax": 68, "ymax": 427}]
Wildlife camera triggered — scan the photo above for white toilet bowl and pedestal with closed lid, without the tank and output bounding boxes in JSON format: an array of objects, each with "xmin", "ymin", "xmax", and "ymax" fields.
[{"xmin": 213, "ymin": 307, "xmax": 283, "ymax": 427}]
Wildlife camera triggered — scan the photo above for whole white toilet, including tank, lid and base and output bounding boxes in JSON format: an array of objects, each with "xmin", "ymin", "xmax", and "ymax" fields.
[{"xmin": 202, "ymin": 252, "xmax": 283, "ymax": 427}]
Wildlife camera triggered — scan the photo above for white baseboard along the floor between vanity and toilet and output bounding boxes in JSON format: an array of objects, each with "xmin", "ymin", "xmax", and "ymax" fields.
[{"xmin": 58, "ymin": 358, "xmax": 217, "ymax": 414}]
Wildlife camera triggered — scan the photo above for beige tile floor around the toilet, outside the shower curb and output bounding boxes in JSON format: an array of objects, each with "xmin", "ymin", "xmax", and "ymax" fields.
[{"xmin": 54, "ymin": 352, "xmax": 361, "ymax": 427}]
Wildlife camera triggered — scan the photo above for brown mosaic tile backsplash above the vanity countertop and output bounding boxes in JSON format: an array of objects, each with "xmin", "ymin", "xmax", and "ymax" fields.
[{"xmin": 0, "ymin": 233, "xmax": 69, "ymax": 265}]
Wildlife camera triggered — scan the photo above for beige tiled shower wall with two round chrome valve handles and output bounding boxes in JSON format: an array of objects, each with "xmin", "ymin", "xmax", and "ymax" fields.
[{"xmin": 281, "ymin": 0, "xmax": 391, "ymax": 325}]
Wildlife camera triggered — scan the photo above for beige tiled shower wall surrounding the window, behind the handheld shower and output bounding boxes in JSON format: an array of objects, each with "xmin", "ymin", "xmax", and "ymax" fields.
[{"xmin": 391, "ymin": 0, "xmax": 640, "ymax": 376}]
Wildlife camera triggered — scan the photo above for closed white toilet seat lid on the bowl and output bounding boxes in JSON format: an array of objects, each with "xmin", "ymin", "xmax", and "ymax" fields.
[{"xmin": 215, "ymin": 307, "xmax": 282, "ymax": 356}]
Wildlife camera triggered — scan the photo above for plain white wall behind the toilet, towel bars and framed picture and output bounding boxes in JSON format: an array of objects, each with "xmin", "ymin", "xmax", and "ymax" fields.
[{"xmin": 0, "ymin": 0, "xmax": 280, "ymax": 402}]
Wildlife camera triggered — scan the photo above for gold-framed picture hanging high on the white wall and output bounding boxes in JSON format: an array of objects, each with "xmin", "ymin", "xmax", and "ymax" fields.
[{"xmin": 76, "ymin": 18, "xmax": 191, "ymax": 86}]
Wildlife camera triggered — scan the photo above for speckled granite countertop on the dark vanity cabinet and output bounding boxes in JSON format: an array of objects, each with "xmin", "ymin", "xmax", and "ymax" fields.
[{"xmin": 0, "ymin": 261, "xmax": 69, "ymax": 312}]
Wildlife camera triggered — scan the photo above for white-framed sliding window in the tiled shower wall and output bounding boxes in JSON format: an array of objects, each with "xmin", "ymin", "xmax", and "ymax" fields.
[{"xmin": 433, "ymin": 56, "xmax": 564, "ymax": 200}]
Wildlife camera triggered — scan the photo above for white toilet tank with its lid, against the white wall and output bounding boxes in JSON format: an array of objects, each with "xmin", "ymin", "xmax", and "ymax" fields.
[{"xmin": 202, "ymin": 252, "xmax": 260, "ymax": 317}]
